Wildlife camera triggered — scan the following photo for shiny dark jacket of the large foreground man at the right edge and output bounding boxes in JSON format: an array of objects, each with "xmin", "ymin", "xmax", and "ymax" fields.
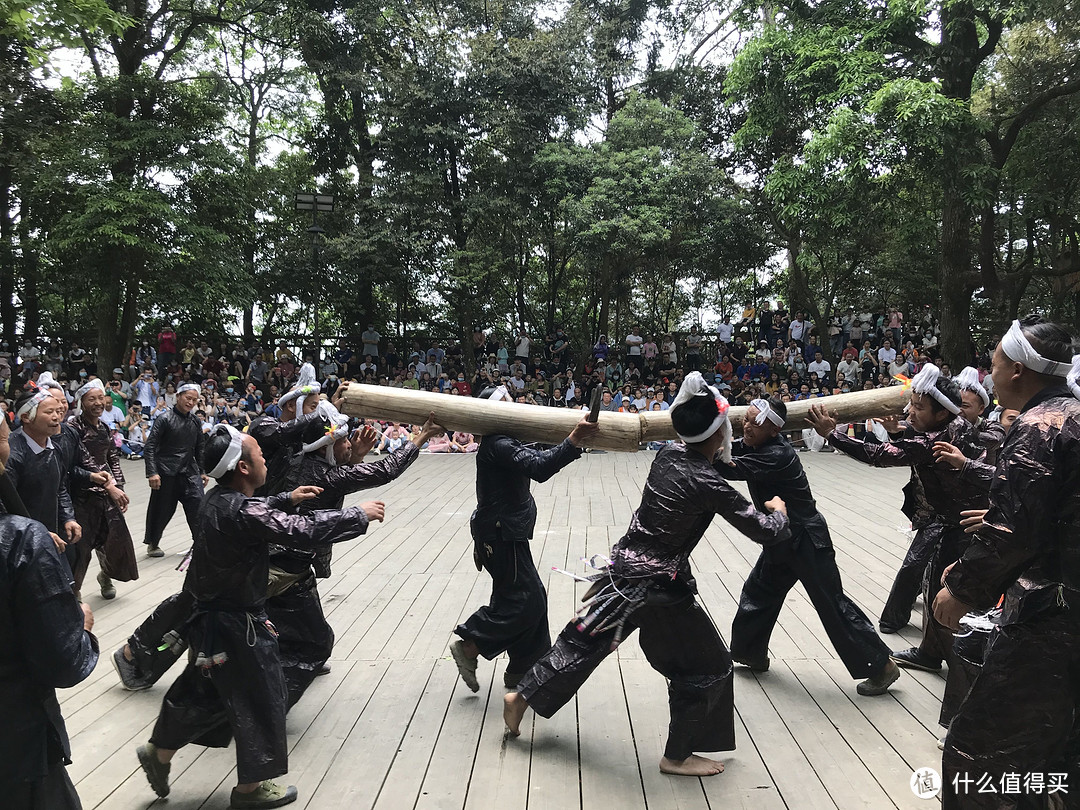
[{"xmin": 945, "ymin": 386, "xmax": 1080, "ymax": 630}]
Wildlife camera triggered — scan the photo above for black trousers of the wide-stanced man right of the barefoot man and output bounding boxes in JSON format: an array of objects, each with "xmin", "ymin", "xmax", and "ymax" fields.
[{"xmin": 731, "ymin": 535, "xmax": 889, "ymax": 678}]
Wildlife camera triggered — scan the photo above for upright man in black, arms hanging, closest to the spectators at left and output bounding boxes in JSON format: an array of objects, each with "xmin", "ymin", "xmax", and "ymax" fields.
[{"xmin": 143, "ymin": 382, "xmax": 206, "ymax": 557}]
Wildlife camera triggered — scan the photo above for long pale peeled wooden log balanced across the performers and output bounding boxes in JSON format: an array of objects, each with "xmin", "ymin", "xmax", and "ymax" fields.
[{"xmin": 341, "ymin": 382, "xmax": 907, "ymax": 453}]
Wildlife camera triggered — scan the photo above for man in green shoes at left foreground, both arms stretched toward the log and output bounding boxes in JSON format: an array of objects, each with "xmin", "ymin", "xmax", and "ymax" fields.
[{"xmin": 138, "ymin": 426, "xmax": 384, "ymax": 808}]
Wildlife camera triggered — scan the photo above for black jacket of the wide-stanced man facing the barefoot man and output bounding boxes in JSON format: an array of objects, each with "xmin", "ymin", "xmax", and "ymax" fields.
[{"xmin": 713, "ymin": 436, "xmax": 833, "ymax": 549}]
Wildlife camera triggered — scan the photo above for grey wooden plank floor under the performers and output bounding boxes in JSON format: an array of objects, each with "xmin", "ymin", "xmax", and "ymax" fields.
[{"xmin": 59, "ymin": 453, "xmax": 944, "ymax": 810}]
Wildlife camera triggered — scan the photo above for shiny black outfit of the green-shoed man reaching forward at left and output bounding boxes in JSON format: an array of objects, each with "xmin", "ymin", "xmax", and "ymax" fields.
[{"xmin": 150, "ymin": 484, "xmax": 367, "ymax": 782}]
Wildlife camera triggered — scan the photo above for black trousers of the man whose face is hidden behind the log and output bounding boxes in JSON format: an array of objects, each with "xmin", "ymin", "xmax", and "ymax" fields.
[{"xmin": 454, "ymin": 538, "xmax": 551, "ymax": 674}]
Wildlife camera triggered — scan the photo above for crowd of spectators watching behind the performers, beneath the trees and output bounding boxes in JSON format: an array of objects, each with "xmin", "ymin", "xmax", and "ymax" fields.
[{"xmin": 0, "ymin": 302, "xmax": 990, "ymax": 457}]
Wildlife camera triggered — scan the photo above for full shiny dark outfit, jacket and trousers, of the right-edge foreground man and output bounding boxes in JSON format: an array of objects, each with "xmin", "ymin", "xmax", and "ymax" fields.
[{"xmin": 943, "ymin": 386, "xmax": 1080, "ymax": 808}]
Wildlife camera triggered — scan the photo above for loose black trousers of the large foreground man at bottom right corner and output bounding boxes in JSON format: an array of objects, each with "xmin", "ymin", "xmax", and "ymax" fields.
[{"xmin": 942, "ymin": 608, "xmax": 1080, "ymax": 810}]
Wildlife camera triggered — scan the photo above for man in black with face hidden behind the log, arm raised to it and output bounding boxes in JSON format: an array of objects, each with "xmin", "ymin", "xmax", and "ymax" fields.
[{"xmin": 450, "ymin": 387, "xmax": 597, "ymax": 692}]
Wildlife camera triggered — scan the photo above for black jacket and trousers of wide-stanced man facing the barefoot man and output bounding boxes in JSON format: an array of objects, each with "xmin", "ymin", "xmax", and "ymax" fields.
[{"xmin": 714, "ymin": 436, "xmax": 889, "ymax": 678}]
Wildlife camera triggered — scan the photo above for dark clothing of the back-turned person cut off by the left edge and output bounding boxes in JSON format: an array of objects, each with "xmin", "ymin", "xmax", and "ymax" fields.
[{"xmin": 0, "ymin": 515, "xmax": 98, "ymax": 797}]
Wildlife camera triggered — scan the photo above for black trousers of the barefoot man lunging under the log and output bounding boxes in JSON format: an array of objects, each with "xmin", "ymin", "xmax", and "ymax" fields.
[{"xmin": 518, "ymin": 597, "xmax": 735, "ymax": 760}]
